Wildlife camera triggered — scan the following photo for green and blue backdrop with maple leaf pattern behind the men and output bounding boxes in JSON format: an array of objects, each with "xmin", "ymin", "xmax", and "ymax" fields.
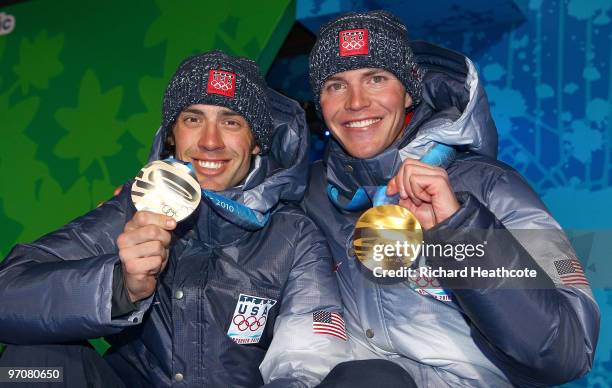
[{"xmin": 0, "ymin": 0, "xmax": 612, "ymax": 387}]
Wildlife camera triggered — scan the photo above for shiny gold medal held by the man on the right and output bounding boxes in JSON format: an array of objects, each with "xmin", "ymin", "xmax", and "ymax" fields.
[{"xmin": 353, "ymin": 205, "xmax": 423, "ymax": 271}]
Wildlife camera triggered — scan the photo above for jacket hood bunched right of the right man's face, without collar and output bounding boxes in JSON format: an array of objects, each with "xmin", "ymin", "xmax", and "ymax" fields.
[{"xmin": 400, "ymin": 41, "xmax": 497, "ymax": 159}]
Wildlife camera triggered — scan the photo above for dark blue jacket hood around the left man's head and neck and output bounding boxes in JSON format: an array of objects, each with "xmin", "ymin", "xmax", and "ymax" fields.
[{"xmin": 144, "ymin": 89, "xmax": 309, "ymax": 238}]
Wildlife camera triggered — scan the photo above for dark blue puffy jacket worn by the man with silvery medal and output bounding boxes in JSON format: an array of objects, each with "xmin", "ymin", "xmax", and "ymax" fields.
[{"xmin": 0, "ymin": 92, "xmax": 349, "ymax": 387}]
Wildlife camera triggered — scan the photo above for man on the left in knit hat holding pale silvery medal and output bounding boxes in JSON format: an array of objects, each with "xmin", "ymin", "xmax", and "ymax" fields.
[{"xmin": 0, "ymin": 51, "xmax": 350, "ymax": 387}]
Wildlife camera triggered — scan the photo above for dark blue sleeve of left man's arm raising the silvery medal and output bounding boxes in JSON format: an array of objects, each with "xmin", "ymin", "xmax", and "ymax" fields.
[{"xmin": 0, "ymin": 183, "xmax": 151, "ymax": 344}]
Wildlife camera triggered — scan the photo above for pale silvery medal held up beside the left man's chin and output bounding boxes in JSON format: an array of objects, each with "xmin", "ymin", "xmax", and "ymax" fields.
[{"xmin": 132, "ymin": 160, "xmax": 202, "ymax": 222}]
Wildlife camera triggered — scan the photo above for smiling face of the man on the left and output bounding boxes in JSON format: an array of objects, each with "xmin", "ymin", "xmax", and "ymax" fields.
[{"xmin": 171, "ymin": 104, "xmax": 259, "ymax": 191}]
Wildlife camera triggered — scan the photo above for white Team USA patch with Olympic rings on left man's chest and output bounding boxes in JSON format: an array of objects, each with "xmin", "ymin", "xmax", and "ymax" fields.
[{"xmin": 227, "ymin": 294, "xmax": 276, "ymax": 344}]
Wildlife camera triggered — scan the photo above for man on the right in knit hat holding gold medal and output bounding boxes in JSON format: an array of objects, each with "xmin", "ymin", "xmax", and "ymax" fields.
[{"xmin": 304, "ymin": 11, "xmax": 599, "ymax": 387}]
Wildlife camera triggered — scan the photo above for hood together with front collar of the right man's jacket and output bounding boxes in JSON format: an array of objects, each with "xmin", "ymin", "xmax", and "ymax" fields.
[{"xmin": 325, "ymin": 41, "xmax": 497, "ymax": 194}]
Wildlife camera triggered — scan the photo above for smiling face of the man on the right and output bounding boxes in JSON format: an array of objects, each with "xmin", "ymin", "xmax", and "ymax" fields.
[{"xmin": 320, "ymin": 69, "xmax": 412, "ymax": 159}]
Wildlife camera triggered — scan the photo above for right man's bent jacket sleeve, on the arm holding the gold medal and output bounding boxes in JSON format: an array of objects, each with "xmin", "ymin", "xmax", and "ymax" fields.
[{"xmin": 426, "ymin": 171, "xmax": 599, "ymax": 386}]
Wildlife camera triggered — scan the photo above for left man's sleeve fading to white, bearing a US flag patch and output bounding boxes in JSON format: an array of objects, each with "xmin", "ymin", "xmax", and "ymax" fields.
[{"xmin": 259, "ymin": 217, "xmax": 350, "ymax": 387}]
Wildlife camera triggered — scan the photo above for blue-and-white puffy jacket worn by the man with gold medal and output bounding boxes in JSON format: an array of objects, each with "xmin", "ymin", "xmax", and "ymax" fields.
[{"xmin": 304, "ymin": 42, "xmax": 599, "ymax": 387}]
